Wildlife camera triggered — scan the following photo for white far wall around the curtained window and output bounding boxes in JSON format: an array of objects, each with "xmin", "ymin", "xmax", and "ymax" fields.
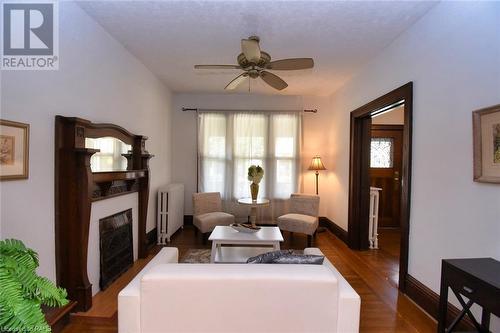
[{"xmin": 172, "ymin": 94, "xmax": 329, "ymax": 214}]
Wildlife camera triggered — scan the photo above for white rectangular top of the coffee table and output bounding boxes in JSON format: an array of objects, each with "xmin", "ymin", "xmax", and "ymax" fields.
[{"xmin": 208, "ymin": 225, "xmax": 283, "ymax": 244}]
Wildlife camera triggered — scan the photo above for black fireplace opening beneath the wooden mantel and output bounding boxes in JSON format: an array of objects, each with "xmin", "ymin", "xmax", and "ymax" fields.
[{"xmin": 99, "ymin": 209, "xmax": 134, "ymax": 290}]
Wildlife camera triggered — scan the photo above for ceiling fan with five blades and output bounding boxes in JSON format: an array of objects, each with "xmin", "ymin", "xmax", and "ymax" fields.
[{"xmin": 194, "ymin": 36, "xmax": 314, "ymax": 90}]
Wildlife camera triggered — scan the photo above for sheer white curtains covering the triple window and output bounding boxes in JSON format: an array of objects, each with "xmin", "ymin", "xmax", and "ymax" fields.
[{"xmin": 198, "ymin": 111, "xmax": 302, "ymax": 222}]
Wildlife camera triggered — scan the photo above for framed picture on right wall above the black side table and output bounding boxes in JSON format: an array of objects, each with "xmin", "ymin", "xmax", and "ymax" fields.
[{"xmin": 472, "ymin": 104, "xmax": 500, "ymax": 184}]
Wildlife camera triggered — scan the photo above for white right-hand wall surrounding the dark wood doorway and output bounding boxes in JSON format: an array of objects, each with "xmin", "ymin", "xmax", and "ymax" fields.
[{"xmin": 318, "ymin": 2, "xmax": 500, "ymax": 300}]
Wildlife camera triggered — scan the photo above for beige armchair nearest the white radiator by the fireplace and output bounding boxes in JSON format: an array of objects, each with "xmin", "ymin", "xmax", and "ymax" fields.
[{"xmin": 193, "ymin": 192, "xmax": 234, "ymax": 239}]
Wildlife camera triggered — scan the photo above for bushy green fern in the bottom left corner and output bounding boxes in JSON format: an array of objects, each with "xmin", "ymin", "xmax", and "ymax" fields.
[{"xmin": 0, "ymin": 239, "xmax": 68, "ymax": 333}]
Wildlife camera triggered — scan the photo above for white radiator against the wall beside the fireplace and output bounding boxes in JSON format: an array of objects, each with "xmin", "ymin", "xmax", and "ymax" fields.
[{"xmin": 156, "ymin": 184, "xmax": 184, "ymax": 244}]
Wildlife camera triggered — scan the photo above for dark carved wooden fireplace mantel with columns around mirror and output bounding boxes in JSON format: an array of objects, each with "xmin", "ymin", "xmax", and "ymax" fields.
[{"xmin": 55, "ymin": 116, "xmax": 153, "ymax": 311}]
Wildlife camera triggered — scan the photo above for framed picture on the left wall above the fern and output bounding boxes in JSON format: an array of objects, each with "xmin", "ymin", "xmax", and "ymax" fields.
[{"xmin": 0, "ymin": 119, "xmax": 30, "ymax": 181}]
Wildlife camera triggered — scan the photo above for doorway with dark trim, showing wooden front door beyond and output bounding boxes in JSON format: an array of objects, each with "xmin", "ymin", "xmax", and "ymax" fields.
[{"xmin": 348, "ymin": 82, "xmax": 413, "ymax": 292}]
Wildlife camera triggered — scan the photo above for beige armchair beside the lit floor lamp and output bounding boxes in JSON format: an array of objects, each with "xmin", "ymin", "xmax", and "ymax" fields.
[{"xmin": 278, "ymin": 194, "xmax": 319, "ymax": 247}]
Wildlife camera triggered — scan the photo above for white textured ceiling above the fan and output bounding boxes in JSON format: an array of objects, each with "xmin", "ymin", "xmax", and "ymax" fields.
[{"xmin": 79, "ymin": 1, "xmax": 435, "ymax": 95}]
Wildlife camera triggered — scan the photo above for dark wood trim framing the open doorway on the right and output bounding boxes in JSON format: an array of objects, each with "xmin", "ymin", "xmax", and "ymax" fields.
[{"xmin": 347, "ymin": 82, "xmax": 413, "ymax": 292}]
